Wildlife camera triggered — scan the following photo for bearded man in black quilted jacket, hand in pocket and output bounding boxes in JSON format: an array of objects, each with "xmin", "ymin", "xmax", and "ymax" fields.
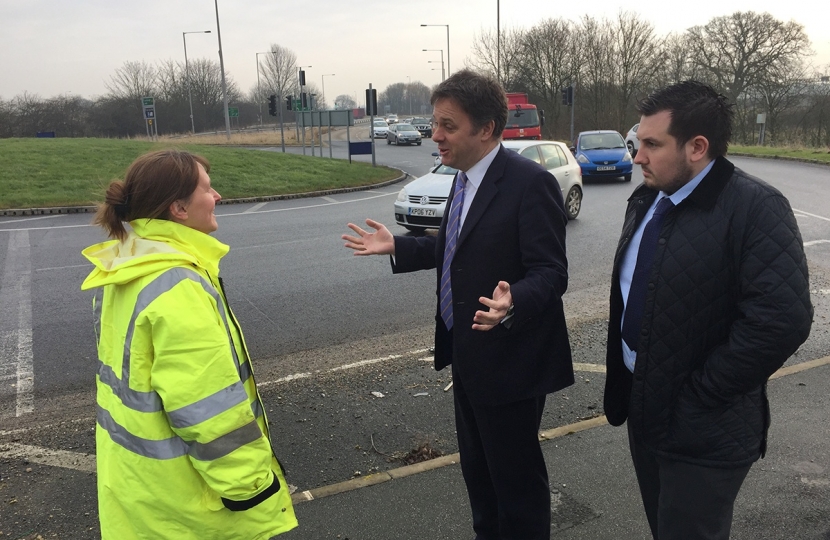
[{"xmin": 605, "ymin": 81, "xmax": 813, "ymax": 540}]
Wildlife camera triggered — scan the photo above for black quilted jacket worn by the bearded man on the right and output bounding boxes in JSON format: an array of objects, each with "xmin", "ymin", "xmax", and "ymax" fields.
[{"xmin": 605, "ymin": 158, "xmax": 813, "ymax": 467}]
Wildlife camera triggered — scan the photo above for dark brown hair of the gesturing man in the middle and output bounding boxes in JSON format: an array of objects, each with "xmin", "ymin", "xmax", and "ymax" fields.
[{"xmin": 429, "ymin": 69, "xmax": 507, "ymax": 139}]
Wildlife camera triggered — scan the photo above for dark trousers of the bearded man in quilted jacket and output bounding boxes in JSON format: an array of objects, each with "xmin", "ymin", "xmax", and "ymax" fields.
[{"xmin": 628, "ymin": 425, "xmax": 752, "ymax": 540}]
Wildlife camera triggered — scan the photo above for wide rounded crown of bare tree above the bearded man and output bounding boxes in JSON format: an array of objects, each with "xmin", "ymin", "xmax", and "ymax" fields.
[{"xmin": 686, "ymin": 11, "xmax": 810, "ymax": 103}]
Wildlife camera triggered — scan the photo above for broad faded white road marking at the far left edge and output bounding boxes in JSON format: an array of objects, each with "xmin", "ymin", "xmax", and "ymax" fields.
[{"xmin": 0, "ymin": 231, "xmax": 34, "ymax": 416}]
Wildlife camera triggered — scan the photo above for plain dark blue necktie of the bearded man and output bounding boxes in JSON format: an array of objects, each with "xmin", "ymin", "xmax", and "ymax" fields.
[{"xmin": 622, "ymin": 197, "xmax": 674, "ymax": 351}]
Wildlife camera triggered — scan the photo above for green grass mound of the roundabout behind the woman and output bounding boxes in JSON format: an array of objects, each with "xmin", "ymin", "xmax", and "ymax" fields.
[{"xmin": 0, "ymin": 139, "xmax": 400, "ymax": 209}]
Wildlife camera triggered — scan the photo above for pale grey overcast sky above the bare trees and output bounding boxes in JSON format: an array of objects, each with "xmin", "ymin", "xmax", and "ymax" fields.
[{"xmin": 0, "ymin": 0, "xmax": 830, "ymax": 102}]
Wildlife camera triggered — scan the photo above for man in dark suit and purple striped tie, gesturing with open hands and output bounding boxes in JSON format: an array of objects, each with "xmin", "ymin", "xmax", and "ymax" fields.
[{"xmin": 343, "ymin": 70, "xmax": 574, "ymax": 540}]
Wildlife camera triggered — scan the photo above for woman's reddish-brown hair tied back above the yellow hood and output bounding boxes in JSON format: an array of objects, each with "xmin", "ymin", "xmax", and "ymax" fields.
[{"xmin": 93, "ymin": 149, "xmax": 210, "ymax": 240}]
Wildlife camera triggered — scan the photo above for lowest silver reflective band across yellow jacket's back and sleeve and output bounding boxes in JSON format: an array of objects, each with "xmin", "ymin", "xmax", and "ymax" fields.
[{"xmin": 97, "ymin": 405, "xmax": 262, "ymax": 461}]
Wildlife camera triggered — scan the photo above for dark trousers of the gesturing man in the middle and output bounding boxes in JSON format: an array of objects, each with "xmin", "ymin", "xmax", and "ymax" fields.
[{"xmin": 453, "ymin": 362, "xmax": 550, "ymax": 540}]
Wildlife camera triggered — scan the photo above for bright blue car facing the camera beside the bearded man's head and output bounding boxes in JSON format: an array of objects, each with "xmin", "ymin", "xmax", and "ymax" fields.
[{"xmin": 571, "ymin": 130, "xmax": 634, "ymax": 182}]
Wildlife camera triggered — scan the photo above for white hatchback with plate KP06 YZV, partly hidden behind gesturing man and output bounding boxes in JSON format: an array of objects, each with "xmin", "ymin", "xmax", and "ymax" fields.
[{"xmin": 394, "ymin": 140, "xmax": 582, "ymax": 232}]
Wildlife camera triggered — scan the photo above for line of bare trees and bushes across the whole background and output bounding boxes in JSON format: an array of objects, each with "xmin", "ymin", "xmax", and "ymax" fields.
[{"xmin": 0, "ymin": 11, "xmax": 830, "ymax": 146}]
